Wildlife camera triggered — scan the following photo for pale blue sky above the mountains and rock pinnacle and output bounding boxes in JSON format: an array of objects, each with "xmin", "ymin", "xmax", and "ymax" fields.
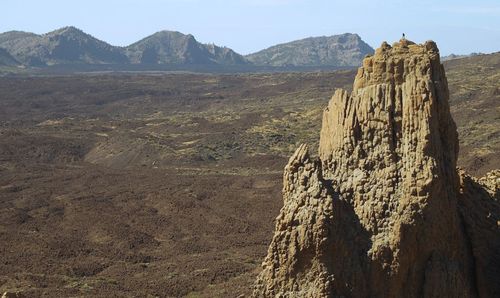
[{"xmin": 0, "ymin": 0, "xmax": 500, "ymax": 55}]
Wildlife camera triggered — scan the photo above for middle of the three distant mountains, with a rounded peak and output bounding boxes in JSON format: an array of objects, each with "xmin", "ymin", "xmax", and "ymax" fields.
[{"xmin": 126, "ymin": 31, "xmax": 247, "ymax": 65}]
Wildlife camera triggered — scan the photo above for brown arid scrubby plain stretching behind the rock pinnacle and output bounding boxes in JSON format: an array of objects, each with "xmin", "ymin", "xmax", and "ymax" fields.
[{"xmin": 0, "ymin": 54, "xmax": 500, "ymax": 297}]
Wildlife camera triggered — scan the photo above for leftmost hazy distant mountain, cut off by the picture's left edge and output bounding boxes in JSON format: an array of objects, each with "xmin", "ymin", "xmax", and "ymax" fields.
[{"xmin": 0, "ymin": 27, "xmax": 128, "ymax": 66}]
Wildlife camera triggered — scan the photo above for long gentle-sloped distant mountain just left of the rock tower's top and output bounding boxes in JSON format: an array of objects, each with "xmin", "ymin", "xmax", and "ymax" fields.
[{"xmin": 245, "ymin": 33, "xmax": 373, "ymax": 67}]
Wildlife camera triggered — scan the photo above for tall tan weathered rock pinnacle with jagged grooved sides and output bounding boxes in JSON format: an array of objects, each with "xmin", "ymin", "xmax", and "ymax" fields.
[{"xmin": 254, "ymin": 40, "xmax": 500, "ymax": 297}]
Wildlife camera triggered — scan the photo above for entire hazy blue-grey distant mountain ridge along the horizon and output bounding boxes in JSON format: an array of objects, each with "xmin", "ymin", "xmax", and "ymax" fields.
[{"xmin": 0, "ymin": 26, "xmax": 373, "ymax": 70}]
